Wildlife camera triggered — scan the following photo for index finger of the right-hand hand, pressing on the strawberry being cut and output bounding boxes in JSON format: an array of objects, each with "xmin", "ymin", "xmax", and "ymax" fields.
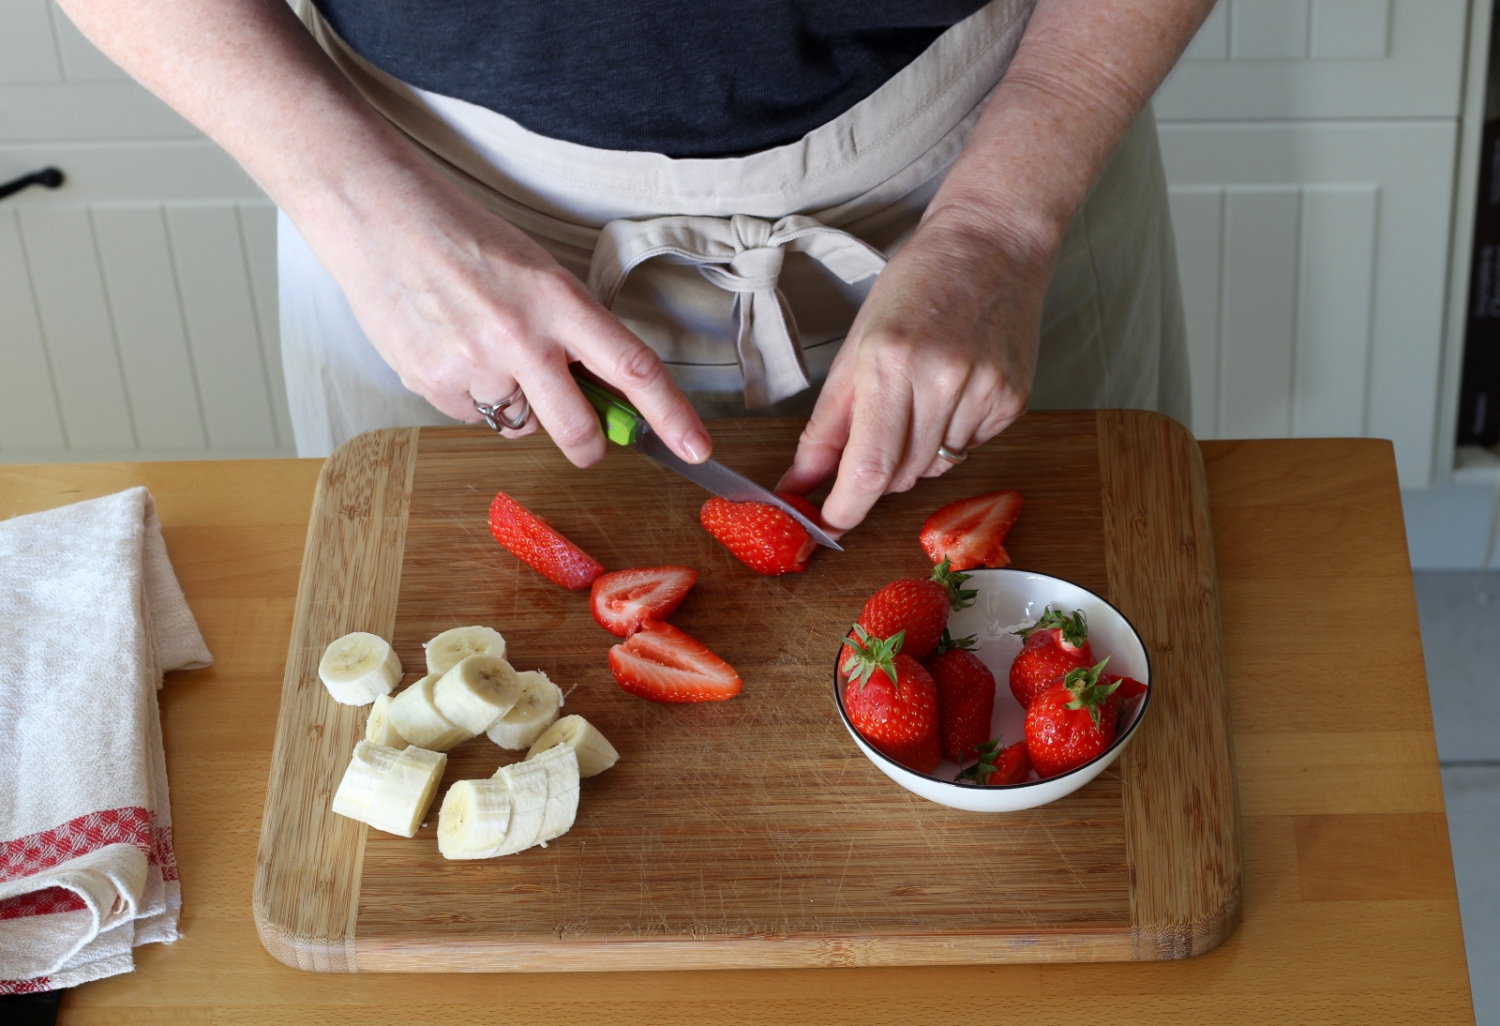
[{"xmin": 822, "ymin": 375, "xmax": 912, "ymax": 531}]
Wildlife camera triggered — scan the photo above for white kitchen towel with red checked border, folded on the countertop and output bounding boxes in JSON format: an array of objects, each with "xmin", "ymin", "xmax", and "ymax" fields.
[{"xmin": 0, "ymin": 488, "xmax": 213, "ymax": 995}]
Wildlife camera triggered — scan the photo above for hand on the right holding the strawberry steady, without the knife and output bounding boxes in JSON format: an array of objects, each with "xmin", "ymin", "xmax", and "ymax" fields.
[{"xmin": 777, "ymin": 207, "xmax": 1056, "ymax": 533}]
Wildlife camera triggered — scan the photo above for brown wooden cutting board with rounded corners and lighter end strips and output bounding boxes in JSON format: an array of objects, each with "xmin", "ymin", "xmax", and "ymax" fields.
[{"xmin": 254, "ymin": 411, "xmax": 1241, "ymax": 972}]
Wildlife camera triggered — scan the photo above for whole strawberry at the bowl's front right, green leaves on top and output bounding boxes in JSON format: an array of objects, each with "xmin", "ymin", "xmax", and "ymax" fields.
[{"xmin": 1026, "ymin": 660, "xmax": 1121, "ymax": 779}]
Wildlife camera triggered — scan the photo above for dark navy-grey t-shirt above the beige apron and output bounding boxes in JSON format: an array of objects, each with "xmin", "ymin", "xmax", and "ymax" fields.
[{"xmin": 315, "ymin": 0, "xmax": 984, "ymax": 158}]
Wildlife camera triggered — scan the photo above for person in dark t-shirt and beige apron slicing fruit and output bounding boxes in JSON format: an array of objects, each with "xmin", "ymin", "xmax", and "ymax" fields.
[{"xmin": 62, "ymin": 0, "xmax": 1212, "ymax": 531}]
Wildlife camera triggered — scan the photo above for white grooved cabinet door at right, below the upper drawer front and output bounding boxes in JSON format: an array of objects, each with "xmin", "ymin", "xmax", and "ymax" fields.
[{"xmin": 1161, "ymin": 122, "xmax": 1457, "ymax": 486}]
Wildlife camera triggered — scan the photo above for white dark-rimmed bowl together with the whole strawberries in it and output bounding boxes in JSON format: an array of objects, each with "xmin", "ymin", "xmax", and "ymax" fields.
[{"xmin": 834, "ymin": 561, "xmax": 1151, "ymax": 812}]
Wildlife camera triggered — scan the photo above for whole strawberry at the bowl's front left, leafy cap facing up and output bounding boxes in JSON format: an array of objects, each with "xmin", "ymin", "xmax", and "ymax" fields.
[{"xmin": 842, "ymin": 624, "xmax": 942, "ymax": 773}]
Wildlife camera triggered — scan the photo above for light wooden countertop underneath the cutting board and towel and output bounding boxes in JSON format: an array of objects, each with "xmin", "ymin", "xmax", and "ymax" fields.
[{"xmin": 0, "ymin": 440, "xmax": 1473, "ymax": 1026}]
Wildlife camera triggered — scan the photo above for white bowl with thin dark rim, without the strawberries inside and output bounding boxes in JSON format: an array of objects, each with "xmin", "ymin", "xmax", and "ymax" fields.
[{"xmin": 834, "ymin": 569, "xmax": 1151, "ymax": 812}]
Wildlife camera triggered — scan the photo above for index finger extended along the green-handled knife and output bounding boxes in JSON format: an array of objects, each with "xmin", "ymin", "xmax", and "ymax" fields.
[{"xmin": 569, "ymin": 303, "xmax": 714, "ymax": 464}]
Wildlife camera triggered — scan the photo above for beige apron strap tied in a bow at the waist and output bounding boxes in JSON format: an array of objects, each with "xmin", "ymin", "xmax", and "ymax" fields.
[{"xmin": 588, "ymin": 215, "xmax": 885, "ymax": 410}]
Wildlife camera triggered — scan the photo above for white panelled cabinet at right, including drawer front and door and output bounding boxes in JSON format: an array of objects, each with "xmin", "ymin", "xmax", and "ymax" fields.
[{"xmin": 1155, "ymin": 0, "xmax": 1490, "ymax": 488}]
